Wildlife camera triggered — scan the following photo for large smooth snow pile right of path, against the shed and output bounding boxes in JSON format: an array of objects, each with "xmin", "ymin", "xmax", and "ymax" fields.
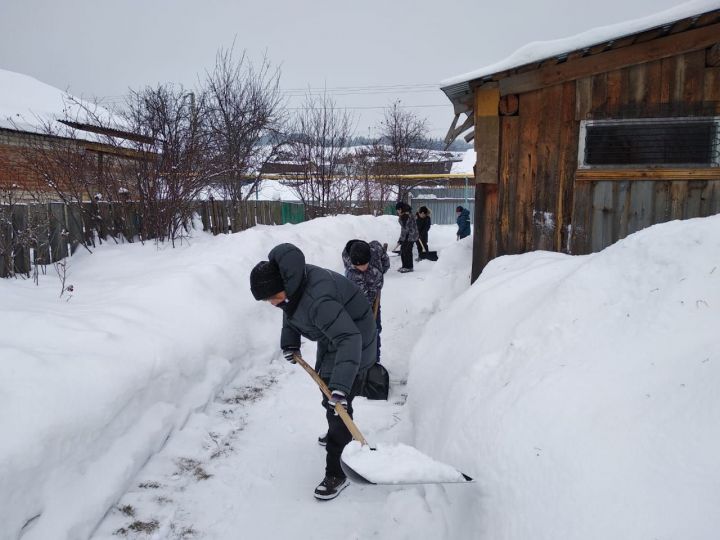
[{"xmin": 408, "ymin": 216, "xmax": 720, "ymax": 540}]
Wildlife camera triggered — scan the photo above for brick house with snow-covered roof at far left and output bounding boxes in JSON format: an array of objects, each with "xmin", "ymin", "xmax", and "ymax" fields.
[{"xmin": 0, "ymin": 70, "xmax": 151, "ymax": 200}]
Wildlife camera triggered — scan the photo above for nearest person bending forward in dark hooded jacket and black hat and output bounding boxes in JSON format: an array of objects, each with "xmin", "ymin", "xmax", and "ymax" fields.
[{"xmin": 250, "ymin": 244, "xmax": 377, "ymax": 500}]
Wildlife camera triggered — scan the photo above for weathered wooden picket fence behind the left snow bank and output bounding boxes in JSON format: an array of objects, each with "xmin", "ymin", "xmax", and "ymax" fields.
[{"xmin": 0, "ymin": 201, "xmax": 305, "ymax": 278}]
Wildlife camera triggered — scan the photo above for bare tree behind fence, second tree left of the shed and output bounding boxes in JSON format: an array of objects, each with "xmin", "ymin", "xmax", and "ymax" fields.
[{"xmin": 288, "ymin": 93, "xmax": 354, "ymax": 218}]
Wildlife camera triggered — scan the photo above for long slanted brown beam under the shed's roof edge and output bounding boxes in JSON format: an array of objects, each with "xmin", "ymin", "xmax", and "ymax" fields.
[{"xmin": 499, "ymin": 23, "xmax": 720, "ymax": 96}]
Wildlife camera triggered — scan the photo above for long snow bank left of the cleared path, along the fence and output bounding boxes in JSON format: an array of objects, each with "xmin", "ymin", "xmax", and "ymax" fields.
[{"xmin": 0, "ymin": 216, "xmax": 398, "ymax": 540}]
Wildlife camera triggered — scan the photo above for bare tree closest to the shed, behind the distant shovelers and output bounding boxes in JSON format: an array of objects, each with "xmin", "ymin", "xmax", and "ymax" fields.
[{"xmin": 374, "ymin": 101, "xmax": 430, "ymax": 201}]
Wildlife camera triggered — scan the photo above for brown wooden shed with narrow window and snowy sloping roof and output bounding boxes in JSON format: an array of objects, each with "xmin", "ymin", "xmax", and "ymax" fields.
[{"xmin": 442, "ymin": 2, "xmax": 720, "ymax": 280}]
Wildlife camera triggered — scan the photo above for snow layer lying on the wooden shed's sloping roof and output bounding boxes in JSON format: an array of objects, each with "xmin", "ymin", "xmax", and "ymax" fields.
[{"xmin": 440, "ymin": 0, "xmax": 720, "ymax": 87}]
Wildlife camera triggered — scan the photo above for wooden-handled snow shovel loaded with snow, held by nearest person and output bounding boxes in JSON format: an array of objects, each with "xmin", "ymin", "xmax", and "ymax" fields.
[{"xmin": 294, "ymin": 354, "xmax": 474, "ymax": 485}]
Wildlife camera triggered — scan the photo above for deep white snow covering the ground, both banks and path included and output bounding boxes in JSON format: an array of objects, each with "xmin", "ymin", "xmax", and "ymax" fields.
[{"xmin": 0, "ymin": 216, "xmax": 720, "ymax": 540}]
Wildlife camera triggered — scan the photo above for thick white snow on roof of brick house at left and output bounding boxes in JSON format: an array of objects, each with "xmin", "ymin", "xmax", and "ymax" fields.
[{"xmin": 0, "ymin": 69, "xmax": 116, "ymax": 140}]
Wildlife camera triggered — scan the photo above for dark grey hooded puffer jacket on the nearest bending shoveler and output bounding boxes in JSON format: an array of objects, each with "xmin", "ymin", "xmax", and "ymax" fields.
[{"xmin": 268, "ymin": 244, "xmax": 377, "ymax": 394}]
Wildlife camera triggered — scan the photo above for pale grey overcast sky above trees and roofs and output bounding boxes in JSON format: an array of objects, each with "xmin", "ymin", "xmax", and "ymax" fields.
[{"xmin": 0, "ymin": 0, "xmax": 683, "ymax": 137}]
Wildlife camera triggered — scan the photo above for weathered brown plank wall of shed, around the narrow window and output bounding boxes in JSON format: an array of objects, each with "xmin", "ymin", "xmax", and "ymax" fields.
[{"xmin": 473, "ymin": 46, "xmax": 720, "ymax": 277}]
